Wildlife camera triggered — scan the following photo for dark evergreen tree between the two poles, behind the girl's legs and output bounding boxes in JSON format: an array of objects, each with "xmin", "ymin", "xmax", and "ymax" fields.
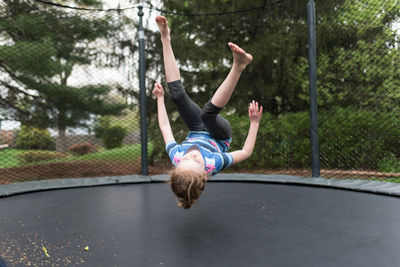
[{"xmin": 145, "ymin": 0, "xmax": 343, "ymax": 115}]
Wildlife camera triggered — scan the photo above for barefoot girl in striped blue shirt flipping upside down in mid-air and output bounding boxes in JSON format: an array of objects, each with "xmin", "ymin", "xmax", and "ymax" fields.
[{"xmin": 153, "ymin": 16, "xmax": 262, "ymax": 209}]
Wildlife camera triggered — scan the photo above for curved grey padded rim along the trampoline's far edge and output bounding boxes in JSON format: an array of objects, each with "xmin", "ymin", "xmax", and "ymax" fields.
[{"xmin": 0, "ymin": 173, "xmax": 400, "ymax": 198}]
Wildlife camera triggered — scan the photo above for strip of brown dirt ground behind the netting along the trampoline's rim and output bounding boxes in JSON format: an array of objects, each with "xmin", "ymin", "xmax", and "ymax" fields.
[{"xmin": 0, "ymin": 161, "xmax": 400, "ymax": 184}]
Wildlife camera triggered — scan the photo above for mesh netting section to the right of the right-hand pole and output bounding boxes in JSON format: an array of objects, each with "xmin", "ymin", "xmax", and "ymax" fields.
[{"xmin": 317, "ymin": 1, "xmax": 400, "ymax": 178}]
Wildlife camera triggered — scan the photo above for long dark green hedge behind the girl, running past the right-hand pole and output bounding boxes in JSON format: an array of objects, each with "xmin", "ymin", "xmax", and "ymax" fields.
[{"xmin": 150, "ymin": 107, "xmax": 400, "ymax": 172}]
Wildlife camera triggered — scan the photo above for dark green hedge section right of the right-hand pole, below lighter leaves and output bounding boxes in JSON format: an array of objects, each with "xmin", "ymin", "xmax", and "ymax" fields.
[{"xmin": 319, "ymin": 108, "xmax": 400, "ymax": 170}]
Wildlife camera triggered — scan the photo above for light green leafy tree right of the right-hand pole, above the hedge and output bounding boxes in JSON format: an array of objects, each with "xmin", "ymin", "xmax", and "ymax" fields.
[{"xmin": 317, "ymin": 0, "xmax": 400, "ymax": 112}]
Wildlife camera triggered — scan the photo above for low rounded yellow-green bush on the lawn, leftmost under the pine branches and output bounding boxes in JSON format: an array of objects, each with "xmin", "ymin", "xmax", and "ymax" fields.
[{"xmin": 16, "ymin": 125, "xmax": 55, "ymax": 150}]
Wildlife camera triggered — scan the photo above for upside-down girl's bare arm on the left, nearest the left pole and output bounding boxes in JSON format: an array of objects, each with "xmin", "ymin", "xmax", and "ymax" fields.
[{"xmin": 153, "ymin": 83, "xmax": 175, "ymax": 144}]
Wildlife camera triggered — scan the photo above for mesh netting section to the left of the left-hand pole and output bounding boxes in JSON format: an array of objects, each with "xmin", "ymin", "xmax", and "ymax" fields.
[{"xmin": 0, "ymin": 1, "xmax": 144, "ymax": 183}]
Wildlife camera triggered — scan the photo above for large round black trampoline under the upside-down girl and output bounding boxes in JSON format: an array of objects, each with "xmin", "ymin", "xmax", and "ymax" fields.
[{"xmin": 0, "ymin": 174, "xmax": 400, "ymax": 267}]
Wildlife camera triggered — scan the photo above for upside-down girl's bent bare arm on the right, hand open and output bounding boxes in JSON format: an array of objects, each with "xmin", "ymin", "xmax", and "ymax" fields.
[{"xmin": 231, "ymin": 100, "xmax": 262, "ymax": 164}]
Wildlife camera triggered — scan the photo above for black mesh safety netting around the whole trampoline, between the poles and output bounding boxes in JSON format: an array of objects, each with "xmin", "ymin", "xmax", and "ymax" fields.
[{"xmin": 0, "ymin": 0, "xmax": 400, "ymax": 184}]
